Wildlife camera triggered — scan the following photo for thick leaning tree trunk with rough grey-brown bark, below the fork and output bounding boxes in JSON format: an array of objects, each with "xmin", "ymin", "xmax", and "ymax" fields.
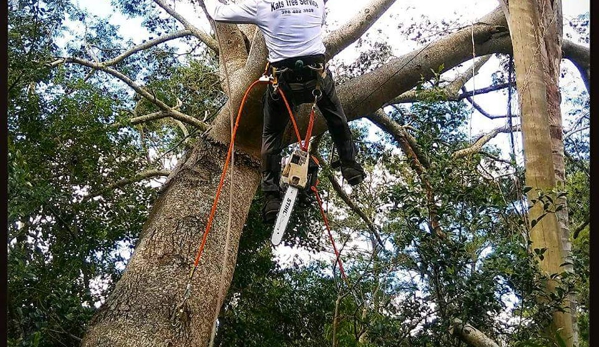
[{"xmin": 82, "ymin": 139, "xmax": 259, "ymax": 347}]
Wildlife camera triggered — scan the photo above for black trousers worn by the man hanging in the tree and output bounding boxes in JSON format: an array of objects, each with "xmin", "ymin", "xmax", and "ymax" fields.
[{"xmin": 261, "ymin": 58, "xmax": 356, "ymax": 192}]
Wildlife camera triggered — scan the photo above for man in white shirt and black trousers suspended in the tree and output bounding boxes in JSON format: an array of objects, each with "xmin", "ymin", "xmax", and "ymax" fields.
[{"xmin": 204, "ymin": 0, "xmax": 366, "ymax": 223}]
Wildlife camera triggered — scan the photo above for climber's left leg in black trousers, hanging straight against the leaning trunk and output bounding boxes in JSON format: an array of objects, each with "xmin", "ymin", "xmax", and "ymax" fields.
[{"xmin": 261, "ymin": 85, "xmax": 289, "ymax": 223}]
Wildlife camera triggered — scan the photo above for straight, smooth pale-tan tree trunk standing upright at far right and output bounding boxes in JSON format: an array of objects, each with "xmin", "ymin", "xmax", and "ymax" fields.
[{"xmin": 509, "ymin": 0, "xmax": 573, "ymax": 346}]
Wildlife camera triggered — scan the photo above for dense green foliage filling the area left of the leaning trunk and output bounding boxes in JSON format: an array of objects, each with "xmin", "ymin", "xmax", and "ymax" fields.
[{"xmin": 7, "ymin": 1, "xmax": 222, "ymax": 346}]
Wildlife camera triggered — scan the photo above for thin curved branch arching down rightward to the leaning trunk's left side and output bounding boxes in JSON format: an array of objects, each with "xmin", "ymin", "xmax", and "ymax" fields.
[{"xmin": 49, "ymin": 58, "xmax": 208, "ymax": 130}]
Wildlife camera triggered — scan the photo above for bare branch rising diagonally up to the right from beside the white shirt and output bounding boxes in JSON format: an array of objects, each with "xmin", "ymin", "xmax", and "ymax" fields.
[{"xmin": 324, "ymin": 0, "xmax": 396, "ymax": 58}]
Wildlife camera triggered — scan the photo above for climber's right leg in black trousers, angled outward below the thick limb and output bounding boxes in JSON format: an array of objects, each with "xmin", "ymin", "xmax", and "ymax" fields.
[{"xmin": 317, "ymin": 70, "xmax": 366, "ymax": 185}]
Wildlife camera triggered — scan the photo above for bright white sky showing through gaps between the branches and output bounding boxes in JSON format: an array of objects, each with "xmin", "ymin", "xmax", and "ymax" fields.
[{"xmin": 65, "ymin": 0, "xmax": 590, "ymax": 282}]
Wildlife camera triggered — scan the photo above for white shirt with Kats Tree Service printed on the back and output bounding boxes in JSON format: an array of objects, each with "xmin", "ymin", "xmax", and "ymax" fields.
[{"xmin": 204, "ymin": 0, "xmax": 325, "ymax": 63}]
